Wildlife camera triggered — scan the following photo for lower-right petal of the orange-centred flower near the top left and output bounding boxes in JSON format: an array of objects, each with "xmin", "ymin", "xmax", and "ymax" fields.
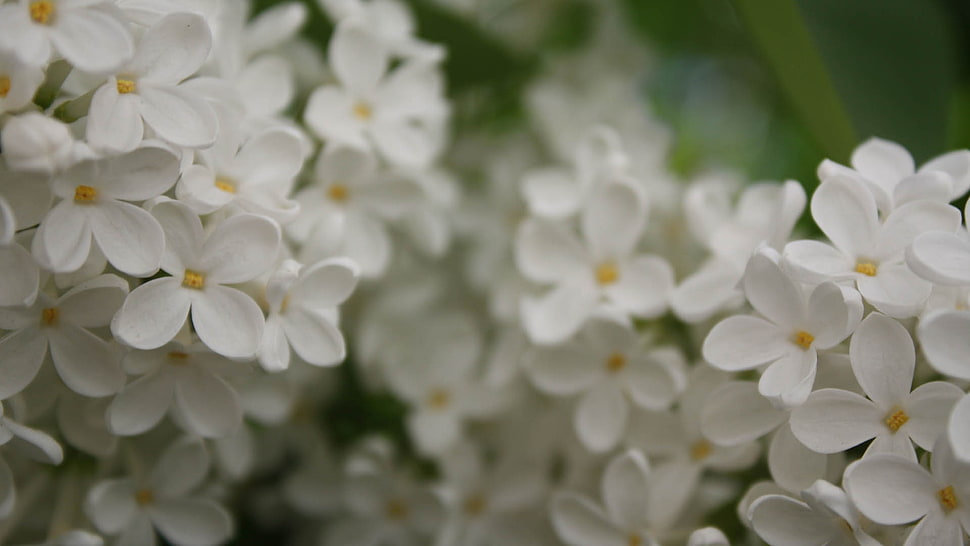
[{"xmin": 138, "ymin": 86, "xmax": 219, "ymax": 148}]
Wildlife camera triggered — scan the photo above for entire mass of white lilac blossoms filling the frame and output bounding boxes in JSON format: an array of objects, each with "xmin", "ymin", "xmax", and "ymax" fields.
[{"xmin": 0, "ymin": 0, "xmax": 970, "ymax": 546}]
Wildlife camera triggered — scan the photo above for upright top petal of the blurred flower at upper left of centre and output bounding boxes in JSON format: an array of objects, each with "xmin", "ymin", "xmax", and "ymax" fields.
[{"xmin": 328, "ymin": 21, "xmax": 388, "ymax": 97}]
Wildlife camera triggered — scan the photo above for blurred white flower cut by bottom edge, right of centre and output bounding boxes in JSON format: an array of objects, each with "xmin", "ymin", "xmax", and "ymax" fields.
[{"xmin": 551, "ymin": 450, "xmax": 679, "ymax": 546}]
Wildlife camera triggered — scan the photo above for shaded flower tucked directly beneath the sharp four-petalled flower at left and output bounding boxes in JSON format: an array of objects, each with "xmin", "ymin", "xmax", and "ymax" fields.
[{"xmin": 106, "ymin": 342, "xmax": 244, "ymax": 437}]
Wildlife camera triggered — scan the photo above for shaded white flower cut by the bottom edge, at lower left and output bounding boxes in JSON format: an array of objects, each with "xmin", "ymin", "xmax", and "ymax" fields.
[{"xmin": 85, "ymin": 437, "xmax": 232, "ymax": 546}]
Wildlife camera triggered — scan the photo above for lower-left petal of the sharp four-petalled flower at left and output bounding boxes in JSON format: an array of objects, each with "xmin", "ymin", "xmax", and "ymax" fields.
[{"xmin": 111, "ymin": 277, "xmax": 192, "ymax": 349}]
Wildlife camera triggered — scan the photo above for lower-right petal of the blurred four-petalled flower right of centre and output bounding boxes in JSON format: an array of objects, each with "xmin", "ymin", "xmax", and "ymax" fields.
[{"xmin": 603, "ymin": 255, "xmax": 674, "ymax": 317}]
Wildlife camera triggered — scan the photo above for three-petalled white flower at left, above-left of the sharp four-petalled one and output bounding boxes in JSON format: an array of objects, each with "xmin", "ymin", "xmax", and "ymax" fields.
[{"xmin": 33, "ymin": 148, "xmax": 179, "ymax": 277}]
